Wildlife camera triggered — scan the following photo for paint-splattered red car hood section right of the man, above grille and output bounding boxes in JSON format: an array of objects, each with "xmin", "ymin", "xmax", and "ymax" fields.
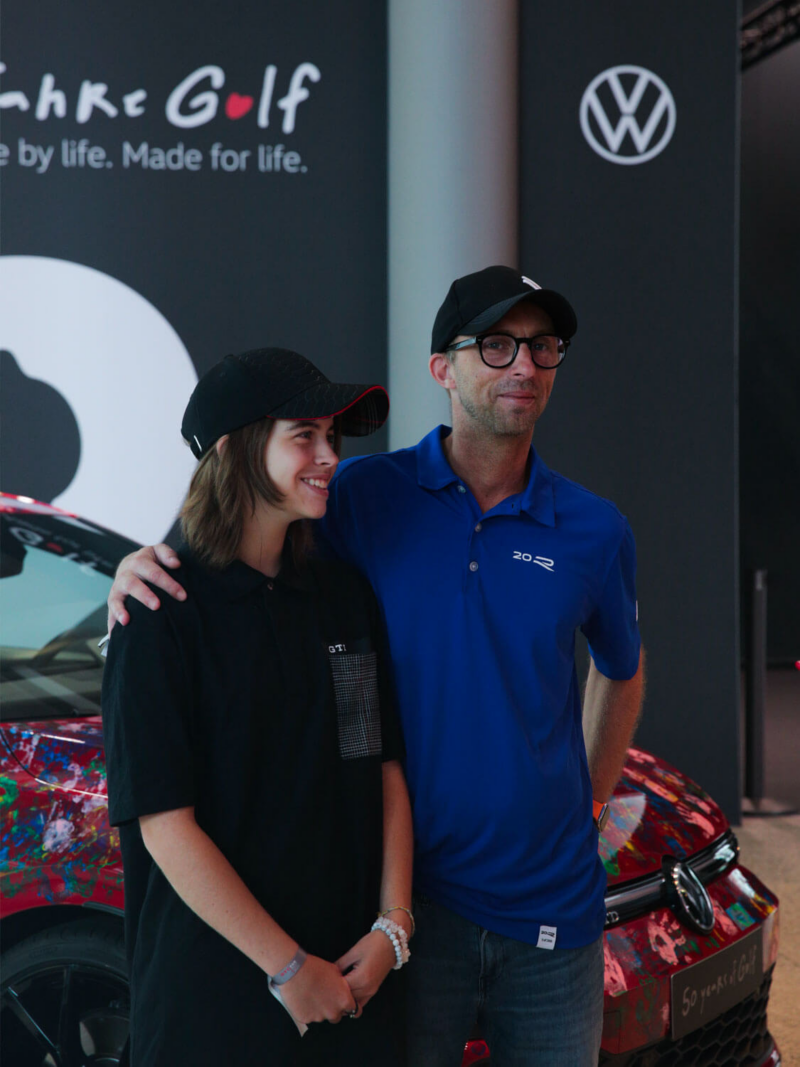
[{"xmin": 599, "ymin": 748, "xmax": 727, "ymax": 886}]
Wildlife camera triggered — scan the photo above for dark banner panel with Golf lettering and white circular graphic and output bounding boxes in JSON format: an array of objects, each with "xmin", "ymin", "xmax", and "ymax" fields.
[{"xmin": 0, "ymin": 0, "xmax": 386, "ymax": 541}]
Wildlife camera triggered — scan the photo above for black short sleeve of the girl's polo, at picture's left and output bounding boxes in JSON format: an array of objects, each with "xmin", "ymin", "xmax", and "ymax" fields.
[{"xmin": 102, "ymin": 601, "xmax": 195, "ymax": 826}]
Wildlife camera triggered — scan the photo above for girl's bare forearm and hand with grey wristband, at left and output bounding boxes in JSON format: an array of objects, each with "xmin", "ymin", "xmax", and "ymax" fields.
[{"xmin": 139, "ymin": 808, "xmax": 356, "ymax": 1023}]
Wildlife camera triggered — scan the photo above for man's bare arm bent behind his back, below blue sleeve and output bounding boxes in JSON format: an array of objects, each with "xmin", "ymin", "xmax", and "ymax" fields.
[{"xmin": 583, "ymin": 649, "xmax": 644, "ymax": 801}]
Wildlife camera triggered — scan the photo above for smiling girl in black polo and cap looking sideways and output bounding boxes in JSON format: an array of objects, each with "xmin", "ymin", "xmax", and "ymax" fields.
[{"xmin": 103, "ymin": 349, "xmax": 413, "ymax": 1067}]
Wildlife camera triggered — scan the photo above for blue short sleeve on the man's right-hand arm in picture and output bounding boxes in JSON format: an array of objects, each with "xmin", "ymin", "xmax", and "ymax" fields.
[{"xmin": 580, "ymin": 522, "xmax": 641, "ymax": 682}]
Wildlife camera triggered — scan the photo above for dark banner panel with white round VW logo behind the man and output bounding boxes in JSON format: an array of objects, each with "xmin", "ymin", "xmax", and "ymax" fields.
[{"xmin": 519, "ymin": 0, "xmax": 740, "ymax": 817}]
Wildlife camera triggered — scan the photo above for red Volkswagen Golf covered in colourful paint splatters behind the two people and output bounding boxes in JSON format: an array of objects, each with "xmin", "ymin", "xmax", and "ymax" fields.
[{"xmin": 0, "ymin": 495, "xmax": 781, "ymax": 1067}]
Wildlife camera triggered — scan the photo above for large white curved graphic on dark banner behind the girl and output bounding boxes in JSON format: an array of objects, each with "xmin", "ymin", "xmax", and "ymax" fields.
[{"xmin": 0, "ymin": 256, "xmax": 197, "ymax": 544}]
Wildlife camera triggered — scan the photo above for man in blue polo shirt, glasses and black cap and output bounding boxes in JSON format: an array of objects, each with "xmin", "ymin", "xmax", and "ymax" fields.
[{"xmin": 109, "ymin": 267, "xmax": 643, "ymax": 1067}]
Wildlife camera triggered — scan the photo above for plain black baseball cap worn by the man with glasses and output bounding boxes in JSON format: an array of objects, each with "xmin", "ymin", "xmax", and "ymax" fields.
[{"xmin": 431, "ymin": 267, "xmax": 578, "ymax": 353}]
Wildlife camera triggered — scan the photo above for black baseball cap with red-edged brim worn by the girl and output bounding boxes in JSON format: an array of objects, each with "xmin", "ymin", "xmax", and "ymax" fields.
[{"xmin": 180, "ymin": 348, "xmax": 389, "ymax": 459}]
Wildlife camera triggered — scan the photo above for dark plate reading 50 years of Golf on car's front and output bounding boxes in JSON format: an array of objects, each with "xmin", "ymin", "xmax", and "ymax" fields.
[{"xmin": 671, "ymin": 926, "xmax": 764, "ymax": 1040}]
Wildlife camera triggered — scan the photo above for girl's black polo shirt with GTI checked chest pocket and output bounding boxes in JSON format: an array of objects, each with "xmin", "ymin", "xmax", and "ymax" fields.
[{"xmin": 102, "ymin": 551, "xmax": 402, "ymax": 1067}]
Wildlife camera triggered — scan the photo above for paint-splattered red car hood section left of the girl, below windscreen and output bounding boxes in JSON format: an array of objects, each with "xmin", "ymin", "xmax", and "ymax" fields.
[{"xmin": 0, "ymin": 716, "xmax": 107, "ymax": 796}]
